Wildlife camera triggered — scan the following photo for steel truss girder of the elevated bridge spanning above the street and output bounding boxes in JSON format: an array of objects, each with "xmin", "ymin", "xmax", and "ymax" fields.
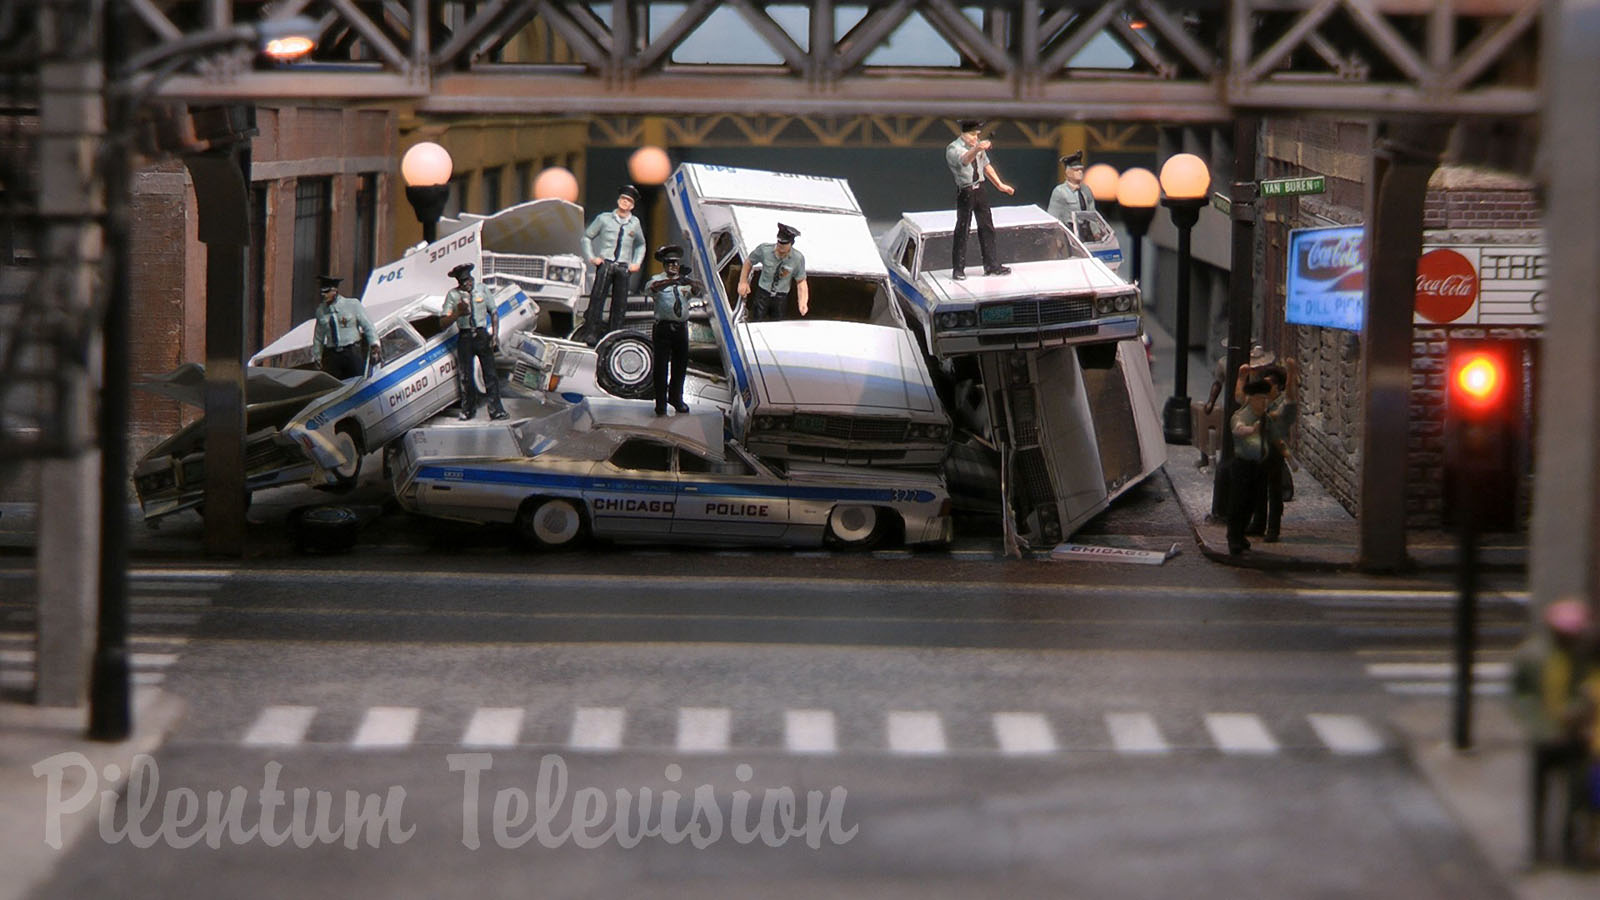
[{"xmin": 131, "ymin": 0, "xmax": 1541, "ymax": 122}]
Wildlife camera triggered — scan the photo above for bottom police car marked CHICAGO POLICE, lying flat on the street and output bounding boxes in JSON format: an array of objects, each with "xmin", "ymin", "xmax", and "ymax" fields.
[{"xmin": 394, "ymin": 397, "xmax": 950, "ymax": 549}]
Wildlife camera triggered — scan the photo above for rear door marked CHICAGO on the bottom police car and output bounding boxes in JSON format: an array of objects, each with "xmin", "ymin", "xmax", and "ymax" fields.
[{"xmin": 584, "ymin": 437, "xmax": 678, "ymax": 538}]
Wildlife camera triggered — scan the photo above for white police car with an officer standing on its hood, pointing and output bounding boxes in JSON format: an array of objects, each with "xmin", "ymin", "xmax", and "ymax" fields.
[{"xmin": 878, "ymin": 205, "xmax": 1141, "ymax": 357}]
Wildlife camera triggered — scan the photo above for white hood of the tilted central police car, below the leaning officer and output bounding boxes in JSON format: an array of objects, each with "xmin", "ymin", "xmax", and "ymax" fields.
[{"xmin": 744, "ymin": 319, "xmax": 939, "ymax": 415}]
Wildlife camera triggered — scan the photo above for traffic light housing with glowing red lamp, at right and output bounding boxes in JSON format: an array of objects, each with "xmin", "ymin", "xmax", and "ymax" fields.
[{"xmin": 1445, "ymin": 343, "xmax": 1522, "ymax": 532}]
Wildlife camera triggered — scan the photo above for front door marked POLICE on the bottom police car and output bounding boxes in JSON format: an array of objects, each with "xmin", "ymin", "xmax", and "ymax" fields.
[{"xmin": 672, "ymin": 447, "xmax": 789, "ymax": 543}]
